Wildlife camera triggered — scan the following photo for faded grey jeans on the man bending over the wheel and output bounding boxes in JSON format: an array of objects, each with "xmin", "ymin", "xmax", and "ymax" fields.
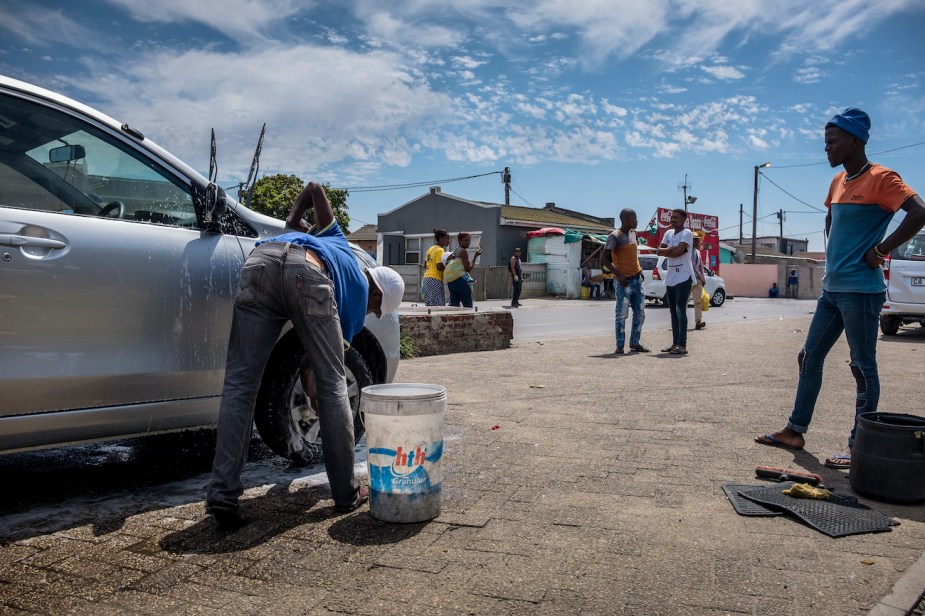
[{"xmin": 206, "ymin": 242, "xmax": 360, "ymax": 511}]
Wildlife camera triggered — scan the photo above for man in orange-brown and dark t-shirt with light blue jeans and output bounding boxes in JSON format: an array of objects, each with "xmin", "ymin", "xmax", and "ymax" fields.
[{"xmin": 601, "ymin": 208, "xmax": 649, "ymax": 355}]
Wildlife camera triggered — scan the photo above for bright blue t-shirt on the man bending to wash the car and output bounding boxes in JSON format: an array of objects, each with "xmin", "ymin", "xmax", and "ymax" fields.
[{"xmin": 260, "ymin": 220, "xmax": 369, "ymax": 343}]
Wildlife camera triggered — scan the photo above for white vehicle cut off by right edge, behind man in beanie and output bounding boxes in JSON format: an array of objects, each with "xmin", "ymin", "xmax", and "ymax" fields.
[{"xmin": 880, "ymin": 233, "xmax": 925, "ymax": 336}]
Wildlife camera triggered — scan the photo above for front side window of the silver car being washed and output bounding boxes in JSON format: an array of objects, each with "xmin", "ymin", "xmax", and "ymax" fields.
[{"xmin": 0, "ymin": 96, "xmax": 198, "ymax": 227}]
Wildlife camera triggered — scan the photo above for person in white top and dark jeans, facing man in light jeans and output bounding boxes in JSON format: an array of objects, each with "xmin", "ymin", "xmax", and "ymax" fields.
[{"xmin": 656, "ymin": 209, "xmax": 694, "ymax": 355}]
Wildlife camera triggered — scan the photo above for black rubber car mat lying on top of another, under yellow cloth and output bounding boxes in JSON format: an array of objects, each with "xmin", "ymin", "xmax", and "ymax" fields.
[{"xmin": 739, "ymin": 481, "xmax": 899, "ymax": 537}]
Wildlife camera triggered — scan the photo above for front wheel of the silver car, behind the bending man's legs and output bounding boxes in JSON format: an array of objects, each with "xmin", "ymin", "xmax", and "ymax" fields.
[{"xmin": 254, "ymin": 344, "xmax": 373, "ymax": 465}]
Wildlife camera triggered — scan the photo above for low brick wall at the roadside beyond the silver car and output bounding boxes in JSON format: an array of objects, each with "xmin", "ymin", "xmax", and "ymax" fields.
[{"xmin": 398, "ymin": 309, "xmax": 514, "ymax": 357}]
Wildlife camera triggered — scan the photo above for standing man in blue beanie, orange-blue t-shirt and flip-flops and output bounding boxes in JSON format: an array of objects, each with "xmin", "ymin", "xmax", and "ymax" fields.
[{"xmin": 755, "ymin": 108, "xmax": 925, "ymax": 468}]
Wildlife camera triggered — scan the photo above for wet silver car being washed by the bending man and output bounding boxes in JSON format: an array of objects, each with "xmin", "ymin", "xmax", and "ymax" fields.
[{"xmin": 0, "ymin": 76, "xmax": 399, "ymax": 463}]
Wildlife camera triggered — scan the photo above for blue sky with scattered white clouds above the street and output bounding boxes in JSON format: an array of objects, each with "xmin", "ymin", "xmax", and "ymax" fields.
[{"xmin": 0, "ymin": 0, "xmax": 925, "ymax": 250}]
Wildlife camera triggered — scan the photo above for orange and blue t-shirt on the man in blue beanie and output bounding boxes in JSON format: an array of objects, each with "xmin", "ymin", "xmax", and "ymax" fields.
[{"xmin": 822, "ymin": 163, "xmax": 916, "ymax": 293}]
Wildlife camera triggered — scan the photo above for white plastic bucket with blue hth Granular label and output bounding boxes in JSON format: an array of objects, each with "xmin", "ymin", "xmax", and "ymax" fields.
[{"xmin": 360, "ymin": 383, "xmax": 446, "ymax": 522}]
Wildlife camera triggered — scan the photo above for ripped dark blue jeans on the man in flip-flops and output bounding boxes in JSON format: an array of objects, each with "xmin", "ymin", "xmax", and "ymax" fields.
[{"xmin": 787, "ymin": 291, "xmax": 886, "ymax": 446}]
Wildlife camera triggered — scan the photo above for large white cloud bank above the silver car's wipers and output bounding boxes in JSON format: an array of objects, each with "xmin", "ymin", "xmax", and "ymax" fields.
[{"xmin": 61, "ymin": 45, "xmax": 454, "ymax": 175}]
